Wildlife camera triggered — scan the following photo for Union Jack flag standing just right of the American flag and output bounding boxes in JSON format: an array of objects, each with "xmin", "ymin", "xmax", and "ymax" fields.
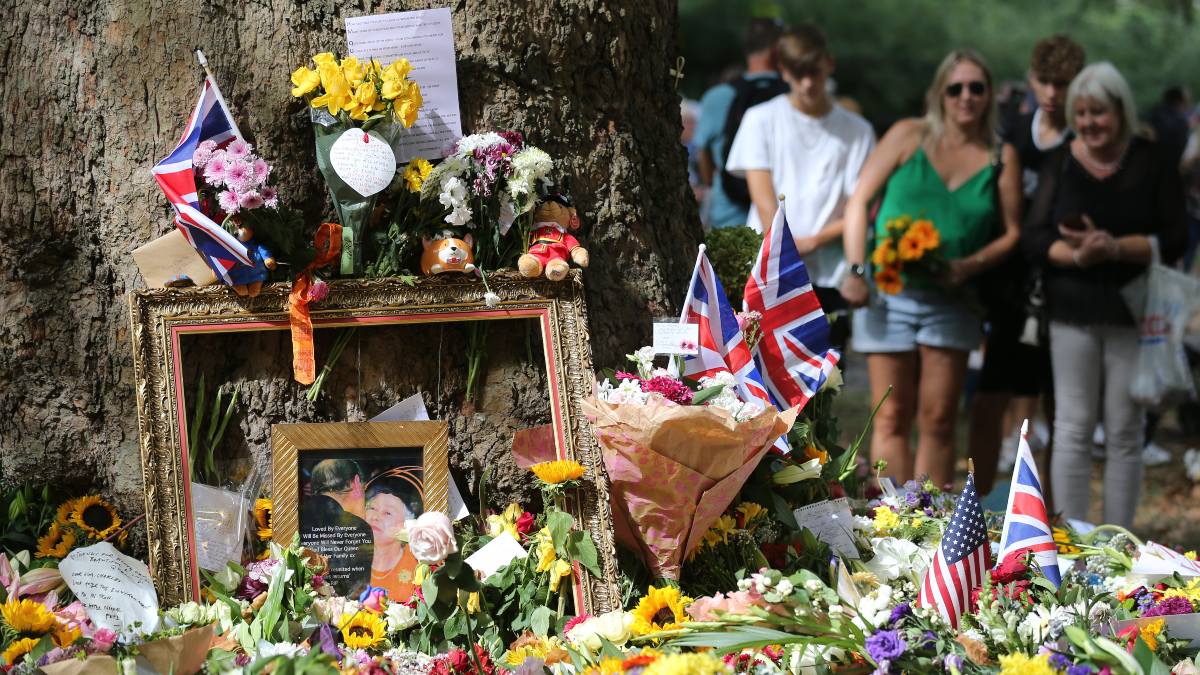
[{"xmin": 1000, "ymin": 419, "xmax": 1062, "ymax": 586}]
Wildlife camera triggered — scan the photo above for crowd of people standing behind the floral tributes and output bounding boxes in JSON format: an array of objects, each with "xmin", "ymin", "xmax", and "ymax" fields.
[{"xmin": 684, "ymin": 19, "xmax": 1200, "ymax": 526}]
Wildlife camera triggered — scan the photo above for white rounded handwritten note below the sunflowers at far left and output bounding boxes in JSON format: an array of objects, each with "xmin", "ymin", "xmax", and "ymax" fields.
[{"xmin": 59, "ymin": 542, "xmax": 158, "ymax": 633}]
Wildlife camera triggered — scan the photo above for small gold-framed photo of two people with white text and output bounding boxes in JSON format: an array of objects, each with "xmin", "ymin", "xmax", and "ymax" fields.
[{"xmin": 271, "ymin": 422, "xmax": 449, "ymax": 601}]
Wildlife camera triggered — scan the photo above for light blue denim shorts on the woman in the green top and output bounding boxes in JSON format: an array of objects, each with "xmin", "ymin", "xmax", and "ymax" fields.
[{"xmin": 851, "ymin": 288, "xmax": 983, "ymax": 354}]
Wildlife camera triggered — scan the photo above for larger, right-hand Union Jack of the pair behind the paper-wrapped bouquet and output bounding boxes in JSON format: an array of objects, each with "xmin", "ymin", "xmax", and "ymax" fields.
[{"xmin": 743, "ymin": 203, "xmax": 839, "ymax": 408}]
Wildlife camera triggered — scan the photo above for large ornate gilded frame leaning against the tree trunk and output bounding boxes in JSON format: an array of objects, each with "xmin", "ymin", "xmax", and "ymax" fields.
[{"xmin": 130, "ymin": 271, "xmax": 620, "ymax": 614}]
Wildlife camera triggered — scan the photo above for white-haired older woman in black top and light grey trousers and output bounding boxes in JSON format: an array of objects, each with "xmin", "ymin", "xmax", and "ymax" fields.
[{"xmin": 1021, "ymin": 62, "xmax": 1187, "ymax": 527}]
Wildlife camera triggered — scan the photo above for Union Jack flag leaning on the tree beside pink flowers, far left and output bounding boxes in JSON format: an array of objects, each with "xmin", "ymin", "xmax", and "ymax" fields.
[{"xmin": 151, "ymin": 76, "xmax": 253, "ymax": 283}]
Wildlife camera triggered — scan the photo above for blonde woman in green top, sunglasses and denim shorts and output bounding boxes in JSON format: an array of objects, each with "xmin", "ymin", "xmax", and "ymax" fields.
[{"xmin": 841, "ymin": 50, "xmax": 1021, "ymax": 485}]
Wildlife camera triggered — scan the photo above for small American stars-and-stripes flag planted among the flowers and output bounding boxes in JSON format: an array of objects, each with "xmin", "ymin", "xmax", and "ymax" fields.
[{"xmin": 917, "ymin": 474, "xmax": 990, "ymax": 627}]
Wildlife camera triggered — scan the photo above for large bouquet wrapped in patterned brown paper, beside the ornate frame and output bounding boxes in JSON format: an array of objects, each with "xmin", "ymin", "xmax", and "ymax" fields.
[{"xmin": 583, "ymin": 351, "xmax": 797, "ymax": 579}]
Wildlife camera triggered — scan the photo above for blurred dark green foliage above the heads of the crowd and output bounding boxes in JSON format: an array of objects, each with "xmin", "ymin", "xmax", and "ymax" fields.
[{"xmin": 679, "ymin": 0, "xmax": 1200, "ymax": 121}]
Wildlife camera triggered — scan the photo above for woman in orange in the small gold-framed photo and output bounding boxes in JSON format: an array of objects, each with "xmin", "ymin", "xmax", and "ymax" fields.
[{"xmin": 366, "ymin": 472, "xmax": 421, "ymax": 603}]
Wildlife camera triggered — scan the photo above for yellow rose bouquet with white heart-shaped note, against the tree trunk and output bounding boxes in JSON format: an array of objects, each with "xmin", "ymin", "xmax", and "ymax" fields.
[{"xmin": 292, "ymin": 52, "xmax": 424, "ymax": 275}]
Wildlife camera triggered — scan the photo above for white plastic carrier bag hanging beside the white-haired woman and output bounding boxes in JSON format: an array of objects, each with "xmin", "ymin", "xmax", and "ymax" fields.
[{"xmin": 1122, "ymin": 264, "xmax": 1200, "ymax": 408}]
